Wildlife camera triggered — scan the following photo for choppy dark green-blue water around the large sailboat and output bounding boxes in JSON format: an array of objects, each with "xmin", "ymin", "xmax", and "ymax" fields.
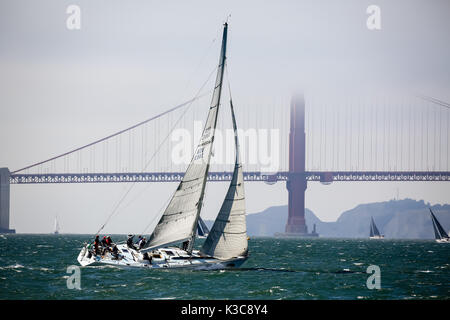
[{"xmin": 0, "ymin": 234, "xmax": 450, "ymax": 300}]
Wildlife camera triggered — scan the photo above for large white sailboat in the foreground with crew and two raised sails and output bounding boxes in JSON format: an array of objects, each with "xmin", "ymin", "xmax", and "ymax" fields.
[{"xmin": 77, "ymin": 23, "xmax": 248, "ymax": 269}]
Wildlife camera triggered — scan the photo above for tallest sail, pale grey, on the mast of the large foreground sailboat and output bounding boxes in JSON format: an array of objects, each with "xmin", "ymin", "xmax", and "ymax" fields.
[{"xmin": 142, "ymin": 23, "xmax": 228, "ymax": 252}]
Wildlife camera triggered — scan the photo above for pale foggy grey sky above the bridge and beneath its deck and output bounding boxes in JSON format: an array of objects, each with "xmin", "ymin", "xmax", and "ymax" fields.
[{"xmin": 0, "ymin": 0, "xmax": 450, "ymax": 233}]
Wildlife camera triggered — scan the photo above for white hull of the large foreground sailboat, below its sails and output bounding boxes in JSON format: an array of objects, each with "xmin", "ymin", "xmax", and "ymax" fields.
[{"xmin": 77, "ymin": 244, "xmax": 247, "ymax": 270}]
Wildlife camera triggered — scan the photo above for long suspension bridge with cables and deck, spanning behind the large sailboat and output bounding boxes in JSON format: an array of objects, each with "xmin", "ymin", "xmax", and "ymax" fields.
[{"xmin": 0, "ymin": 91, "xmax": 450, "ymax": 236}]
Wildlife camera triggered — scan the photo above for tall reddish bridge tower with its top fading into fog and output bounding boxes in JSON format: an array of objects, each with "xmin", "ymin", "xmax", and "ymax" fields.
[{"xmin": 284, "ymin": 95, "xmax": 318, "ymax": 237}]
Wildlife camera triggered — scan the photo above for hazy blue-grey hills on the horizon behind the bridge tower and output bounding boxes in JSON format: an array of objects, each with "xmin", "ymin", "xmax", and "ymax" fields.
[{"xmin": 205, "ymin": 199, "xmax": 450, "ymax": 239}]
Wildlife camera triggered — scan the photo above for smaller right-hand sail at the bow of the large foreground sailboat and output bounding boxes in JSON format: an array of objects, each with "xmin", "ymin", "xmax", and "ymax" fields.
[{"xmin": 200, "ymin": 100, "xmax": 248, "ymax": 259}]
